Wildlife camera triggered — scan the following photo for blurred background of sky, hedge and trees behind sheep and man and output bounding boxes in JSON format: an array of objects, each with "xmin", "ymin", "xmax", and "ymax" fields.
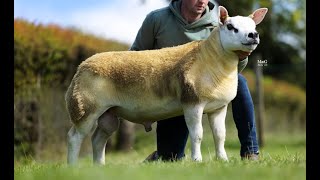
[{"xmin": 14, "ymin": 0, "xmax": 306, "ymax": 162}]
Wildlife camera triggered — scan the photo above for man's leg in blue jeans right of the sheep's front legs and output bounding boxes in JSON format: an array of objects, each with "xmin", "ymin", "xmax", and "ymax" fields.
[{"xmin": 232, "ymin": 74, "xmax": 259, "ymax": 158}]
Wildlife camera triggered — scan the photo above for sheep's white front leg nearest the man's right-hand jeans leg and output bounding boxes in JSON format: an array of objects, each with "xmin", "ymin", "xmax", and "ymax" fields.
[{"xmin": 208, "ymin": 105, "xmax": 228, "ymax": 161}]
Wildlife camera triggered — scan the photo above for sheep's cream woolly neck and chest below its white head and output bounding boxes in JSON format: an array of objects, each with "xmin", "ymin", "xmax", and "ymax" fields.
[{"xmin": 194, "ymin": 29, "xmax": 238, "ymax": 98}]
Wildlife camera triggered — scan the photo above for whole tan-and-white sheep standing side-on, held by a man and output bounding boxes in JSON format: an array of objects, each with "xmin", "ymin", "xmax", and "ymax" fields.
[{"xmin": 65, "ymin": 6, "xmax": 267, "ymax": 164}]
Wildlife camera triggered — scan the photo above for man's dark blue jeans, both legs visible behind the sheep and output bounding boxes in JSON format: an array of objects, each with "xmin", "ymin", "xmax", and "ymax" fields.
[{"xmin": 157, "ymin": 74, "xmax": 259, "ymax": 160}]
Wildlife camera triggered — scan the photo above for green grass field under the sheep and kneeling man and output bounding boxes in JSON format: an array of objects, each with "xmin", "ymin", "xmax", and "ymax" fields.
[{"xmin": 14, "ymin": 123, "xmax": 306, "ymax": 180}]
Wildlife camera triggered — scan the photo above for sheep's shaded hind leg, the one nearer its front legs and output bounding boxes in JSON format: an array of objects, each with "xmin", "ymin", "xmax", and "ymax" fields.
[{"xmin": 91, "ymin": 110, "xmax": 119, "ymax": 165}]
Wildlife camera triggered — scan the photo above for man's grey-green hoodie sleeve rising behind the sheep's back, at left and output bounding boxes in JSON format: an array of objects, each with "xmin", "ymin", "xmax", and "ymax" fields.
[{"xmin": 129, "ymin": 13, "xmax": 155, "ymax": 51}]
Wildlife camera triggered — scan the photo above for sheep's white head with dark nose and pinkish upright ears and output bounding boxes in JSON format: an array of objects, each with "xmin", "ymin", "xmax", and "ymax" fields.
[{"xmin": 219, "ymin": 6, "xmax": 268, "ymax": 56}]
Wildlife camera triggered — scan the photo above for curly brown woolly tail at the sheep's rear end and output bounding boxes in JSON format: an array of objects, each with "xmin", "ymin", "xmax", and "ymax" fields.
[{"xmin": 65, "ymin": 73, "xmax": 85, "ymax": 122}]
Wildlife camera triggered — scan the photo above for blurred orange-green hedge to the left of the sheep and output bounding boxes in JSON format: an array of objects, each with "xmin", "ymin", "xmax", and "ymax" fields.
[{"xmin": 14, "ymin": 19, "xmax": 128, "ymax": 159}]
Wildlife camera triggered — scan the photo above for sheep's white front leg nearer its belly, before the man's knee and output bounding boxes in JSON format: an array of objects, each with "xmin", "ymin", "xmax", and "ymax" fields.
[{"xmin": 183, "ymin": 104, "xmax": 204, "ymax": 162}]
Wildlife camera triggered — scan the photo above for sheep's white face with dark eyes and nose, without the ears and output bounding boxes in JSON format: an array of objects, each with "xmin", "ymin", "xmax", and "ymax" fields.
[{"xmin": 220, "ymin": 16, "xmax": 260, "ymax": 52}]
